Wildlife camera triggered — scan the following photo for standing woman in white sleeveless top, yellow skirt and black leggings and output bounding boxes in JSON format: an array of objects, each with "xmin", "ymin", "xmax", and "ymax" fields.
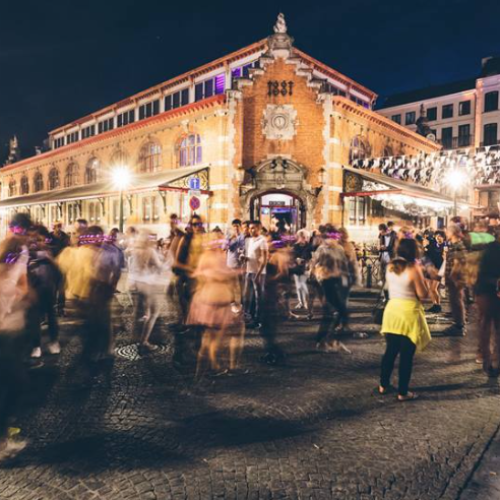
[{"xmin": 378, "ymin": 239, "xmax": 431, "ymax": 401}]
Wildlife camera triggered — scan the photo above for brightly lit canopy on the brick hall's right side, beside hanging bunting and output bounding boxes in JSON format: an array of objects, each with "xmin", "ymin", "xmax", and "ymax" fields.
[{"xmin": 342, "ymin": 167, "xmax": 462, "ymax": 217}]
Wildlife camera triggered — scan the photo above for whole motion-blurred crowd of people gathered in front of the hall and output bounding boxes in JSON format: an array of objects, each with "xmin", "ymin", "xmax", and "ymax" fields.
[{"xmin": 0, "ymin": 209, "xmax": 500, "ymax": 458}]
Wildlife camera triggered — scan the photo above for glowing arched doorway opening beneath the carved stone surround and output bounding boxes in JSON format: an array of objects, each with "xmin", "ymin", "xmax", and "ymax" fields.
[{"xmin": 250, "ymin": 190, "xmax": 306, "ymax": 232}]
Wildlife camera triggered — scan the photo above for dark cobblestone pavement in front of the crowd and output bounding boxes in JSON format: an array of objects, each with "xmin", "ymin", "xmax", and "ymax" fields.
[{"xmin": 0, "ymin": 296, "xmax": 500, "ymax": 500}]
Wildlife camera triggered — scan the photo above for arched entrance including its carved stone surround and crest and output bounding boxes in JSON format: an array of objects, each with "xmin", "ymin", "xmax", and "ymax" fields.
[{"xmin": 240, "ymin": 157, "xmax": 321, "ymax": 230}]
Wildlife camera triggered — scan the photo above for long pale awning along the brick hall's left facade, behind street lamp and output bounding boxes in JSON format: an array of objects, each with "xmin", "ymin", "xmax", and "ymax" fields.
[{"xmin": 0, "ymin": 166, "xmax": 209, "ymax": 208}]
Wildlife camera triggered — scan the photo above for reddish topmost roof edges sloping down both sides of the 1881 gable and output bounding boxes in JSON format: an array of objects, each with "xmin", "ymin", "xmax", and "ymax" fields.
[{"xmin": 49, "ymin": 38, "xmax": 377, "ymax": 136}]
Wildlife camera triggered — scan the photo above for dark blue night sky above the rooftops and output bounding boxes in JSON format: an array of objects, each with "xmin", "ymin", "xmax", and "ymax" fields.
[{"xmin": 0, "ymin": 0, "xmax": 500, "ymax": 164}]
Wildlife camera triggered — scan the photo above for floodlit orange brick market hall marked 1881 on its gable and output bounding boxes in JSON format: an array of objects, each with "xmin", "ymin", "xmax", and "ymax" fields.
[{"xmin": 0, "ymin": 14, "xmax": 440, "ymax": 237}]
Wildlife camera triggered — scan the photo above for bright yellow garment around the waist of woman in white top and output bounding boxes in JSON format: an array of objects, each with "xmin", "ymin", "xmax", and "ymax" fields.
[{"xmin": 380, "ymin": 299, "xmax": 431, "ymax": 351}]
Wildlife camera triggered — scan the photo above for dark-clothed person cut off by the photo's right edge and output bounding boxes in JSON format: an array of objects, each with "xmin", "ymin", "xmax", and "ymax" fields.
[{"xmin": 476, "ymin": 240, "xmax": 500, "ymax": 377}]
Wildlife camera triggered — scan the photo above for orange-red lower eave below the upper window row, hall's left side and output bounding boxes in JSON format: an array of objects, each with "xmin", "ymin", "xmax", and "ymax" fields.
[{"xmin": 0, "ymin": 94, "xmax": 226, "ymax": 177}]
